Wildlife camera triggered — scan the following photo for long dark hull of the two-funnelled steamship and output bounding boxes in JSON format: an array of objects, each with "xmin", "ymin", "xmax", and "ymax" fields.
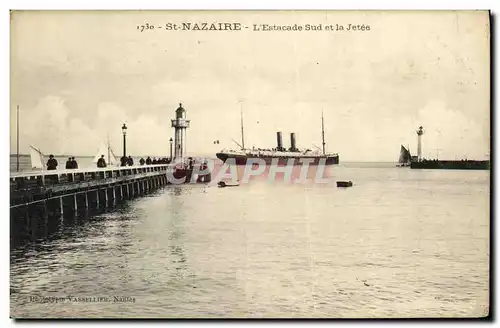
[{"xmin": 216, "ymin": 153, "xmax": 339, "ymax": 165}]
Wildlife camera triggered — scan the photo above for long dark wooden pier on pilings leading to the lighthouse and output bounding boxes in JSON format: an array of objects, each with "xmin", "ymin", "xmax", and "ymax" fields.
[{"xmin": 10, "ymin": 164, "xmax": 210, "ymax": 240}]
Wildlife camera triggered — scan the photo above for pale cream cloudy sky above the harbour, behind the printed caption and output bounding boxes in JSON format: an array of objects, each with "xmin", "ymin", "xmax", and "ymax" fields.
[{"xmin": 10, "ymin": 11, "xmax": 490, "ymax": 161}]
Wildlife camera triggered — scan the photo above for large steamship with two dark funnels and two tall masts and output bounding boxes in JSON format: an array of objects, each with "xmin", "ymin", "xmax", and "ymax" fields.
[{"xmin": 216, "ymin": 111, "xmax": 339, "ymax": 165}]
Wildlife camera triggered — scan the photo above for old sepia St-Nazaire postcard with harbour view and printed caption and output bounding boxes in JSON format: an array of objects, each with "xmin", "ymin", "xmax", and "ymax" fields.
[{"xmin": 10, "ymin": 10, "xmax": 491, "ymax": 319}]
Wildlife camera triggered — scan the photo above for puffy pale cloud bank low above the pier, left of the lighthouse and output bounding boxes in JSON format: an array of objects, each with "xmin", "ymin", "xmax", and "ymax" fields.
[{"xmin": 13, "ymin": 96, "xmax": 176, "ymax": 156}]
